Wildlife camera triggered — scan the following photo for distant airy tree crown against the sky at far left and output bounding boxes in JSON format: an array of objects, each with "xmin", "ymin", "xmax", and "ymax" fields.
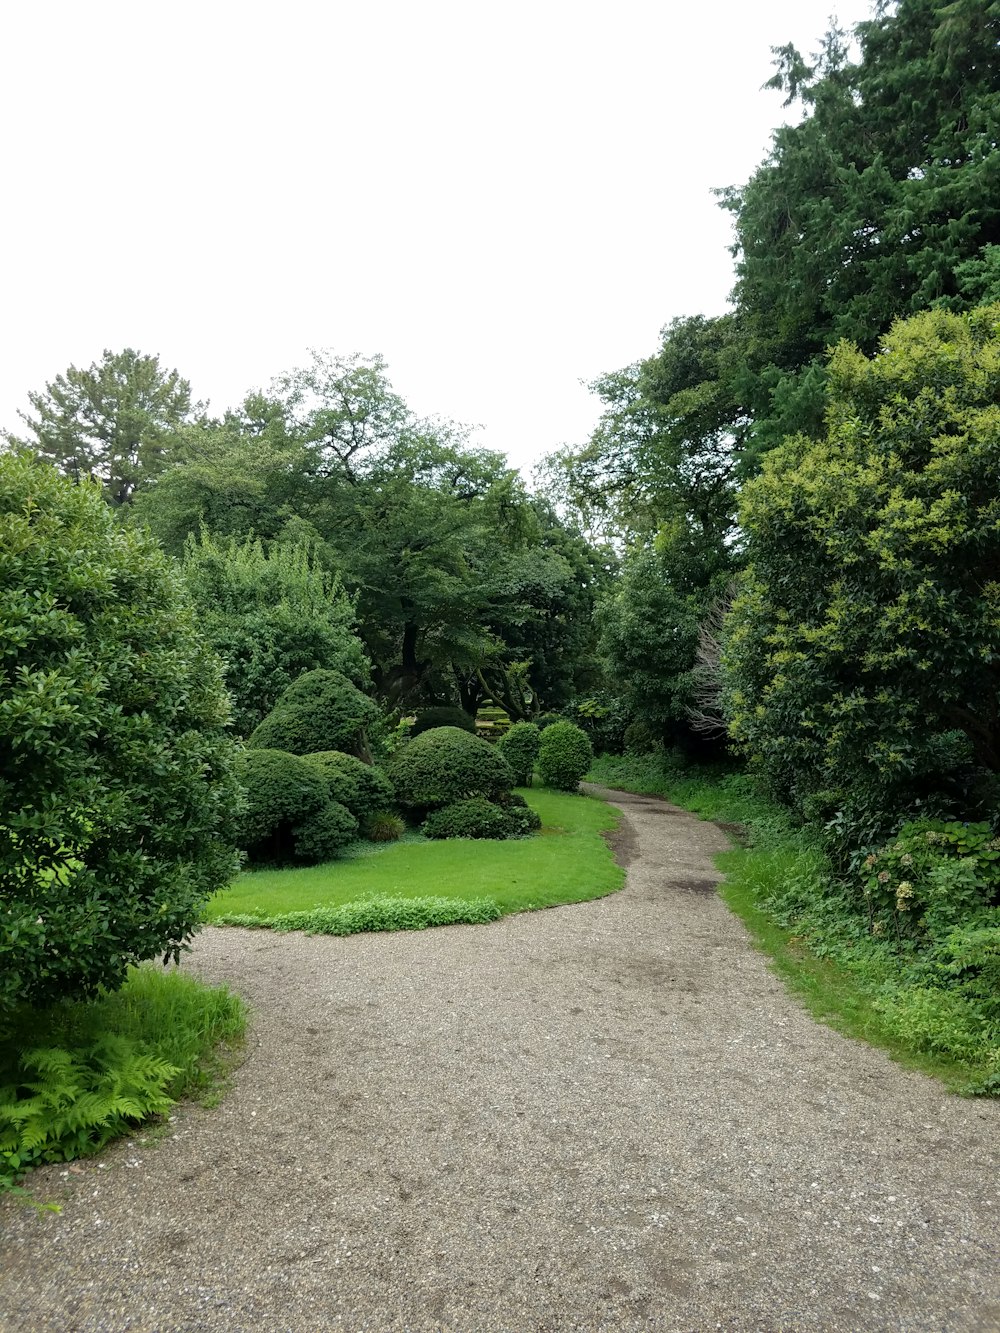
[{"xmin": 13, "ymin": 348, "xmax": 193, "ymax": 505}]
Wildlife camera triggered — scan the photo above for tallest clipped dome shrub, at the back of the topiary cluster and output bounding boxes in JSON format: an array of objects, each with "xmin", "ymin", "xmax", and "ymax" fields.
[{"xmin": 247, "ymin": 670, "xmax": 381, "ymax": 762}]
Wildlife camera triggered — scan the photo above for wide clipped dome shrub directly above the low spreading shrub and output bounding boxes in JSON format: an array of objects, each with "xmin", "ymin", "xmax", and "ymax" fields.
[{"xmin": 388, "ymin": 726, "xmax": 513, "ymax": 813}]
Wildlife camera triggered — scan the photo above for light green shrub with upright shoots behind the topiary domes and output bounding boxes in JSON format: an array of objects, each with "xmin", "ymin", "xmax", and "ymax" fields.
[{"xmin": 184, "ymin": 531, "xmax": 368, "ymax": 736}]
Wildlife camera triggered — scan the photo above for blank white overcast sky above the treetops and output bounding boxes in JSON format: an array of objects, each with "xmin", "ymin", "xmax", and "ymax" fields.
[{"xmin": 0, "ymin": 0, "xmax": 869, "ymax": 468}]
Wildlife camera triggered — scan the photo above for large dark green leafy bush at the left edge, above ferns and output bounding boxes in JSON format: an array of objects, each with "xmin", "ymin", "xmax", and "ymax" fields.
[{"xmin": 0, "ymin": 455, "xmax": 239, "ymax": 1028}]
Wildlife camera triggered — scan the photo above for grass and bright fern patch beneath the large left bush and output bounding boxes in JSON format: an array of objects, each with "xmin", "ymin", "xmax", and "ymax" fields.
[{"xmin": 0, "ymin": 965, "xmax": 247, "ymax": 1192}]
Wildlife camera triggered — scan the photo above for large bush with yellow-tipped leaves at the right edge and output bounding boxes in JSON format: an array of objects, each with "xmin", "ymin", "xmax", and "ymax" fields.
[{"xmin": 724, "ymin": 307, "xmax": 1000, "ymax": 856}]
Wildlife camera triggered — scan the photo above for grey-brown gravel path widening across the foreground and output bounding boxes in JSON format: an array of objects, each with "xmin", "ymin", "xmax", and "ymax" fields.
[{"xmin": 0, "ymin": 793, "xmax": 1000, "ymax": 1333}]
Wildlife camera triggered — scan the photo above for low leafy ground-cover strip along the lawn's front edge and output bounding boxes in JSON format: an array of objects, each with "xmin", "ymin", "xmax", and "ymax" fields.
[{"xmin": 219, "ymin": 896, "xmax": 503, "ymax": 934}]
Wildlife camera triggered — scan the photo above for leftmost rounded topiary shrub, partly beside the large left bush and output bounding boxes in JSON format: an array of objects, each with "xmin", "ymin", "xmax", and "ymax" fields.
[{"xmin": 239, "ymin": 749, "xmax": 329, "ymax": 861}]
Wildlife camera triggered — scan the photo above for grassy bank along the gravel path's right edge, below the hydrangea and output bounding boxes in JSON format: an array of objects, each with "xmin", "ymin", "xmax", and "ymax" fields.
[{"xmin": 589, "ymin": 756, "xmax": 1000, "ymax": 1094}]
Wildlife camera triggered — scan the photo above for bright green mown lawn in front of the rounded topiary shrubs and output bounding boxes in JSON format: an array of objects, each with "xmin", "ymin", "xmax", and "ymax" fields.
[{"xmin": 205, "ymin": 788, "xmax": 624, "ymax": 924}]
